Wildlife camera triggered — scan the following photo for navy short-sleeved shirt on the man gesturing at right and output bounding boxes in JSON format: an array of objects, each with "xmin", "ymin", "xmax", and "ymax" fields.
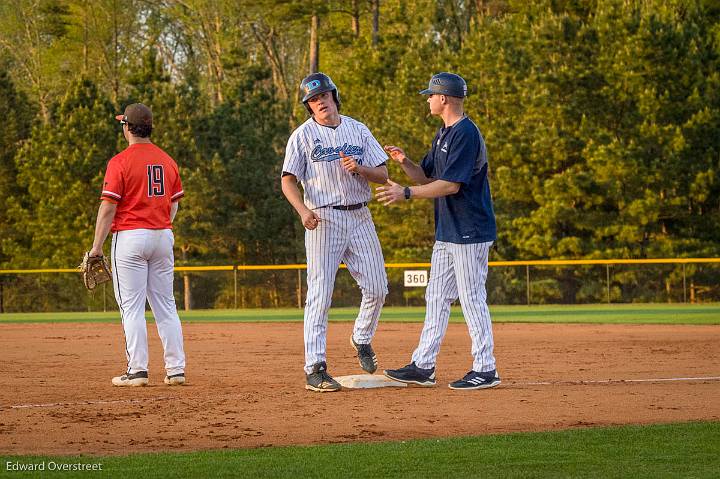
[{"xmin": 420, "ymin": 117, "xmax": 497, "ymax": 244}]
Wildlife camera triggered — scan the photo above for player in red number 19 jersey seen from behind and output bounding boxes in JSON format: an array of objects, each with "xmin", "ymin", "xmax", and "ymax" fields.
[{"xmin": 90, "ymin": 103, "xmax": 185, "ymax": 386}]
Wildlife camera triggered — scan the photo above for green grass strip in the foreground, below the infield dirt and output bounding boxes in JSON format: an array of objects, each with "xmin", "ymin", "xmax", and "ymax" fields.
[{"xmin": 0, "ymin": 418, "xmax": 720, "ymax": 479}]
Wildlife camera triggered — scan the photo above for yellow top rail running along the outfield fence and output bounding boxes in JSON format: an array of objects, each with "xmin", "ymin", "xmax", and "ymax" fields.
[{"xmin": 0, "ymin": 258, "xmax": 720, "ymax": 274}]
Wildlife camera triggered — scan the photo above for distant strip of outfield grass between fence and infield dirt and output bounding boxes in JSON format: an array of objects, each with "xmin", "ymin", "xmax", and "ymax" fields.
[{"xmin": 0, "ymin": 303, "xmax": 720, "ymax": 324}]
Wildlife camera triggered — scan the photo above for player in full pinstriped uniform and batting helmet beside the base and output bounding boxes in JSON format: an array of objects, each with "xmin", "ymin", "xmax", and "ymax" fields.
[{"xmin": 282, "ymin": 73, "xmax": 388, "ymax": 392}]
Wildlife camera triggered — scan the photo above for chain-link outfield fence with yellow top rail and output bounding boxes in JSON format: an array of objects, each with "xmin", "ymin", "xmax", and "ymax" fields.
[{"xmin": 0, "ymin": 258, "xmax": 720, "ymax": 312}]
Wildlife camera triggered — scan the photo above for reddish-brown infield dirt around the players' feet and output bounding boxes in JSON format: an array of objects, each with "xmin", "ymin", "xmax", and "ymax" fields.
[{"xmin": 0, "ymin": 320, "xmax": 720, "ymax": 455}]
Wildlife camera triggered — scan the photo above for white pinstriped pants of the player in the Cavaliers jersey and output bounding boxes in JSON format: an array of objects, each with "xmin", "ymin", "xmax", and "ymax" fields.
[{"xmin": 304, "ymin": 207, "xmax": 388, "ymax": 374}]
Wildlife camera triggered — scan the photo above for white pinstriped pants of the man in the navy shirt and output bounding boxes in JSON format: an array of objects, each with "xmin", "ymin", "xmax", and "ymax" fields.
[{"xmin": 412, "ymin": 241, "xmax": 495, "ymax": 372}]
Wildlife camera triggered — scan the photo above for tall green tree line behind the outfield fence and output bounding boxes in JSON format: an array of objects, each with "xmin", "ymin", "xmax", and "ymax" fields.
[{"xmin": 0, "ymin": 0, "xmax": 720, "ymax": 307}]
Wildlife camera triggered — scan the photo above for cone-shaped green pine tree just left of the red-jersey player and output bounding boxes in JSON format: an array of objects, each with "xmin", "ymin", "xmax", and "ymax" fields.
[{"xmin": 6, "ymin": 79, "xmax": 120, "ymax": 268}]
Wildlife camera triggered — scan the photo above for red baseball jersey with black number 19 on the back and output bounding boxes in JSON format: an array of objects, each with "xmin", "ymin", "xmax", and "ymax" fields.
[{"xmin": 100, "ymin": 143, "xmax": 184, "ymax": 231}]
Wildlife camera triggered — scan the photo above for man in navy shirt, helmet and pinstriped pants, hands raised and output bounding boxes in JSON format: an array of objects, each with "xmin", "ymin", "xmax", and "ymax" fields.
[{"xmin": 376, "ymin": 73, "xmax": 500, "ymax": 390}]
